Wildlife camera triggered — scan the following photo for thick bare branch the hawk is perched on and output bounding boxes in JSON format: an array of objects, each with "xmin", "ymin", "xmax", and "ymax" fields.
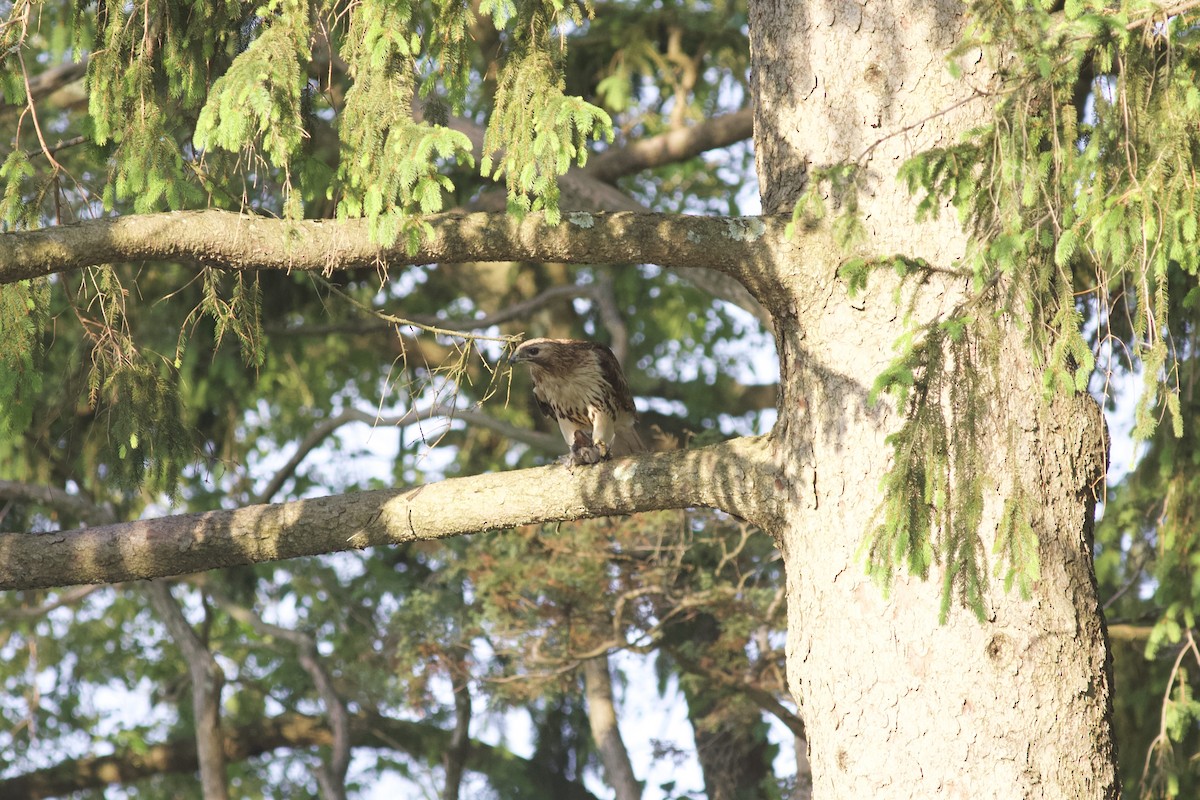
[{"xmin": 0, "ymin": 438, "xmax": 775, "ymax": 589}]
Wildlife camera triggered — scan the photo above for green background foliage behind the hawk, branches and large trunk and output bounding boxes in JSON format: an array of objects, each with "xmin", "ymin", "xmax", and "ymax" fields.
[{"xmin": 0, "ymin": 0, "xmax": 1200, "ymax": 799}]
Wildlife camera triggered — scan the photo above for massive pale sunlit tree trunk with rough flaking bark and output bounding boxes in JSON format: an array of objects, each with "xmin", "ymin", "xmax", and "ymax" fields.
[{"xmin": 750, "ymin": 0, "xmax": 1116, "ymax": 800}]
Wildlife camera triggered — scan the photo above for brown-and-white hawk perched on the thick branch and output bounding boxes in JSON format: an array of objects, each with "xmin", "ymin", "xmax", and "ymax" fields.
[{"xmin": 509, "ymin": 339, "xmax": 646, "ymax": 464}]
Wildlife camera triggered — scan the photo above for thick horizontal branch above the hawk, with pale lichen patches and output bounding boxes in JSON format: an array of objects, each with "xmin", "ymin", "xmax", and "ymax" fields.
[{"xmin": 0, "ymin": 210, "xmax": 806, "ymax": 309}]
